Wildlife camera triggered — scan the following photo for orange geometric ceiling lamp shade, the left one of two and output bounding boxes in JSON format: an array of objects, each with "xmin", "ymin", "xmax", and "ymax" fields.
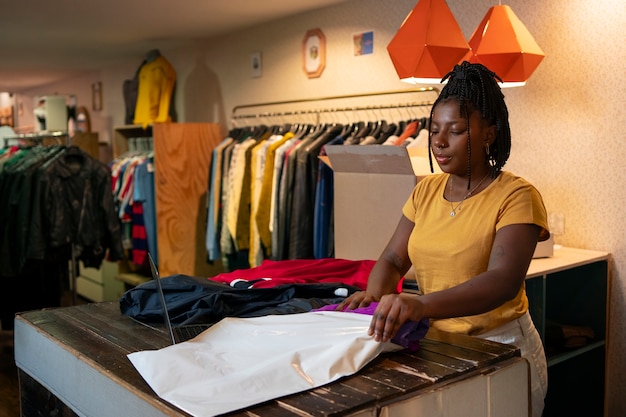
[{"xmin": 387, "ymin": 0, "xmax": 470, "ymax": 84}]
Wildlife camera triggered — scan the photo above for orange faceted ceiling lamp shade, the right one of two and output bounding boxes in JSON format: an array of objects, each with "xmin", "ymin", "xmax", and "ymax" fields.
[{"xmin": 469, "ymin": 5, "xmax": 545, "ymax": 87}]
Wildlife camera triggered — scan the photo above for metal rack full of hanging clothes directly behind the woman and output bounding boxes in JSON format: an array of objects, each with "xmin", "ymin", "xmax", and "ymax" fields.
[{"xmin": 212, "ymin": 87, "xmax": 439, "ymax": 270}]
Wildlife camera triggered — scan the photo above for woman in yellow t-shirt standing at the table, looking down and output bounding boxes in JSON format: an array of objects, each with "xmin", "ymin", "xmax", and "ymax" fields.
[{"xmin": 338, "ymin": 62, "xmax": 549, "ymax": 416}]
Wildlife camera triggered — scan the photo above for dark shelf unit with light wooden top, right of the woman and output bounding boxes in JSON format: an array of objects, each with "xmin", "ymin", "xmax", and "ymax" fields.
[{"xmin": 526, "ymin": 247, "xmax": 610, "ymax": 417}]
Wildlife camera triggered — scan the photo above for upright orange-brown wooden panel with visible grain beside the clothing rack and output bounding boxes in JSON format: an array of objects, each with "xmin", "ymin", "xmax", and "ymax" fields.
[{"xmin": 153, "ymin": 123, "xmax": 223, "ymax": 276}]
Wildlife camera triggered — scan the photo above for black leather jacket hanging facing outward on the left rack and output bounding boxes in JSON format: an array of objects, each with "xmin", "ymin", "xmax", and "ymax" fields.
[{"xmin": 29, "ymin": 146, "xmax": 124, "ymax": 268}]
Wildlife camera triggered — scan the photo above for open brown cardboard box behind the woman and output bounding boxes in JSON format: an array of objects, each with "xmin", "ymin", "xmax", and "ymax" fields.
[{"xmin": 321, "ymin": 145, "xmax": 554, "ymax": 260}]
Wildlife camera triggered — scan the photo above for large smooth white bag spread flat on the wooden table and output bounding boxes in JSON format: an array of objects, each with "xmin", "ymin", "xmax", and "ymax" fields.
[{"xmin": 128, "ymin": 311, "xmax": 402, "ymax": 417}]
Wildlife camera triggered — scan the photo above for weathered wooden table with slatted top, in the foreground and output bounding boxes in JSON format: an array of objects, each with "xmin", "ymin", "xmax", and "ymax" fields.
[{"xmin": 15, "ymin": 302, "xmax": 529, "ymax": 417}]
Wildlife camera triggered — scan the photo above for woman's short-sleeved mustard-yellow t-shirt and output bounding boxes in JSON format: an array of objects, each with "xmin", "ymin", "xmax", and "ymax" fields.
[{"xmin": 402, "ymin": 172, "xmax": 549, "ymax": 335}]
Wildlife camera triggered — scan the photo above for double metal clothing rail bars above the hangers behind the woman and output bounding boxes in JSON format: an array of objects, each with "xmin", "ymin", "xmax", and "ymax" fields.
[{"xmin": 231, "ymin": 87, "xmax": 439, "ymax": 125}]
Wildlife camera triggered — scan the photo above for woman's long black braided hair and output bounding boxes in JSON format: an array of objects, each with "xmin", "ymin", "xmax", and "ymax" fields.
[{"xmin": 428, "ymin": 61, "xmax": 511, "ymax": 189}]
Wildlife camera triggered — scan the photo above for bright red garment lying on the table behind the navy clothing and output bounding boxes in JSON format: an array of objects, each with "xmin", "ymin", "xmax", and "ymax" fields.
[{"xmin": 209, "ymin": 258, "xmax": 402, "ymax": 291}]
